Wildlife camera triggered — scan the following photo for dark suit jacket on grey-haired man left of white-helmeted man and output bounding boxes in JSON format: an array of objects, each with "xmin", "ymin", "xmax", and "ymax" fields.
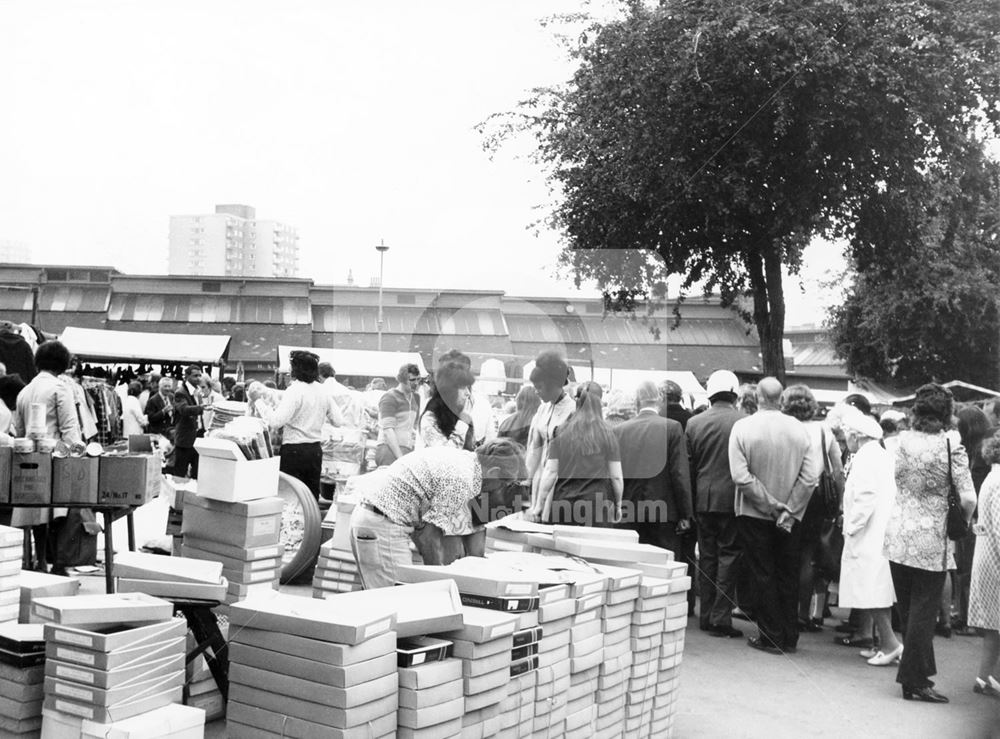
[{"xmin": 614, "ymin": 411, "xmax": 692, "ymax": 521}]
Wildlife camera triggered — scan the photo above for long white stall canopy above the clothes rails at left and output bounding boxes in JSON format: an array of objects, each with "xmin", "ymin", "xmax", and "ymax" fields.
[{"xmin": 59, "ymin": 326, "xmax": 230, "ymax": 364}]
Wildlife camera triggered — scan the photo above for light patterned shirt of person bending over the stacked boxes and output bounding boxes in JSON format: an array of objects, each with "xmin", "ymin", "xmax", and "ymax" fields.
[{"xmin": 363, "ymin": 446, "xmax": 483, "ymax": 535}]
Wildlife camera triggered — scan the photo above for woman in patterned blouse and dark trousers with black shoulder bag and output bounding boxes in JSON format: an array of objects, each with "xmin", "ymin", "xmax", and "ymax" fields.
[{"xmin": 885, "ymin": 384, "xmax": 976, "ymax": 703}]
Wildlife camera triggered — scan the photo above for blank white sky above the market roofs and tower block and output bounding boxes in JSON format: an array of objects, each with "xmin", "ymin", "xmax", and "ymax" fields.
[{"xmin": 0, "ymin": 0, "xmax": 620, "ymax": 297}]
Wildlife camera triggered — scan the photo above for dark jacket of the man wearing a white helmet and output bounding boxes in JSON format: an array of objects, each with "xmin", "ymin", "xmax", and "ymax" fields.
[{"xmin": 687, "ymin": 404, "xmax": 745, "ymax": 515}]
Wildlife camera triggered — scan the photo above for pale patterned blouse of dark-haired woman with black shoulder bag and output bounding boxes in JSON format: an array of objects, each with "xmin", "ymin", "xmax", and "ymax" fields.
[{"xmin": 885, "ymin": 431, "xmax": 974, "ymax": 572}]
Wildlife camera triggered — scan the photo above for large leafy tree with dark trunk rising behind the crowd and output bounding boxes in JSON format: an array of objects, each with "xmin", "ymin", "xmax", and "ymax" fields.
[{"xmin": 487, "ymin": 0, "xmax": 1000, "ymax": 377}]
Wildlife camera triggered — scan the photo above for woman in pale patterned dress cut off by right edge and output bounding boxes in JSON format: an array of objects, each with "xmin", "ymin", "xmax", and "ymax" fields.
[{"xmin": 969, "ymin": 434, "xmax": 1000, "ymax": 698}]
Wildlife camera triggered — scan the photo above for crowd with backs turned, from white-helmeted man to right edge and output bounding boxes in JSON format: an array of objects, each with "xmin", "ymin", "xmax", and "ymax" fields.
[{"xmin": 667, "ymin": 371, "xmax": 988, "ymax": 703}]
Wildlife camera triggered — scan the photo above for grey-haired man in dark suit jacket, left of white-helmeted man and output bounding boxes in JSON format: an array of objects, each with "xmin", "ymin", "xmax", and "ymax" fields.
[{"xmin": 614, "ymin": 382, "xmax": 692, "ymax": 559}]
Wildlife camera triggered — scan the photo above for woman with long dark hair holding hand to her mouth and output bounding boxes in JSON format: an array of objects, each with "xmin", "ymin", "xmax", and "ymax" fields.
[{"xmin": 417, "ymin": 362, "xmax": 476, "ymax": 452}]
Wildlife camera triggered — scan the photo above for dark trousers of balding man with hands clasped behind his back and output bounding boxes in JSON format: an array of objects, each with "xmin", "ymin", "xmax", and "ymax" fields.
[{"xmin": 736, "ymin": 516, "xmax": 802, "ymax": 649}]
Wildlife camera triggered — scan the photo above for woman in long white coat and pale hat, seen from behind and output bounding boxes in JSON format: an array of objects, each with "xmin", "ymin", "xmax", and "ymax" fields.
[{"xmin": 840, "ymin": 408, "xmax": 903, "ymax": 667}]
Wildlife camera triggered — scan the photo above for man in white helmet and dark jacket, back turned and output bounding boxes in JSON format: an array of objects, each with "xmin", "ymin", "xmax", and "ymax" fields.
[{"xmin": 687, "ymin": 370, "xmax": 743, "ymax": 638}]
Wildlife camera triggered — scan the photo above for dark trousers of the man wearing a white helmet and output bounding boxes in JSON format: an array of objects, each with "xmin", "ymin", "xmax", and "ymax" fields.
[{"xmin": 698, "ymin": 513, "xmax": 740, "ymax": 631}]
